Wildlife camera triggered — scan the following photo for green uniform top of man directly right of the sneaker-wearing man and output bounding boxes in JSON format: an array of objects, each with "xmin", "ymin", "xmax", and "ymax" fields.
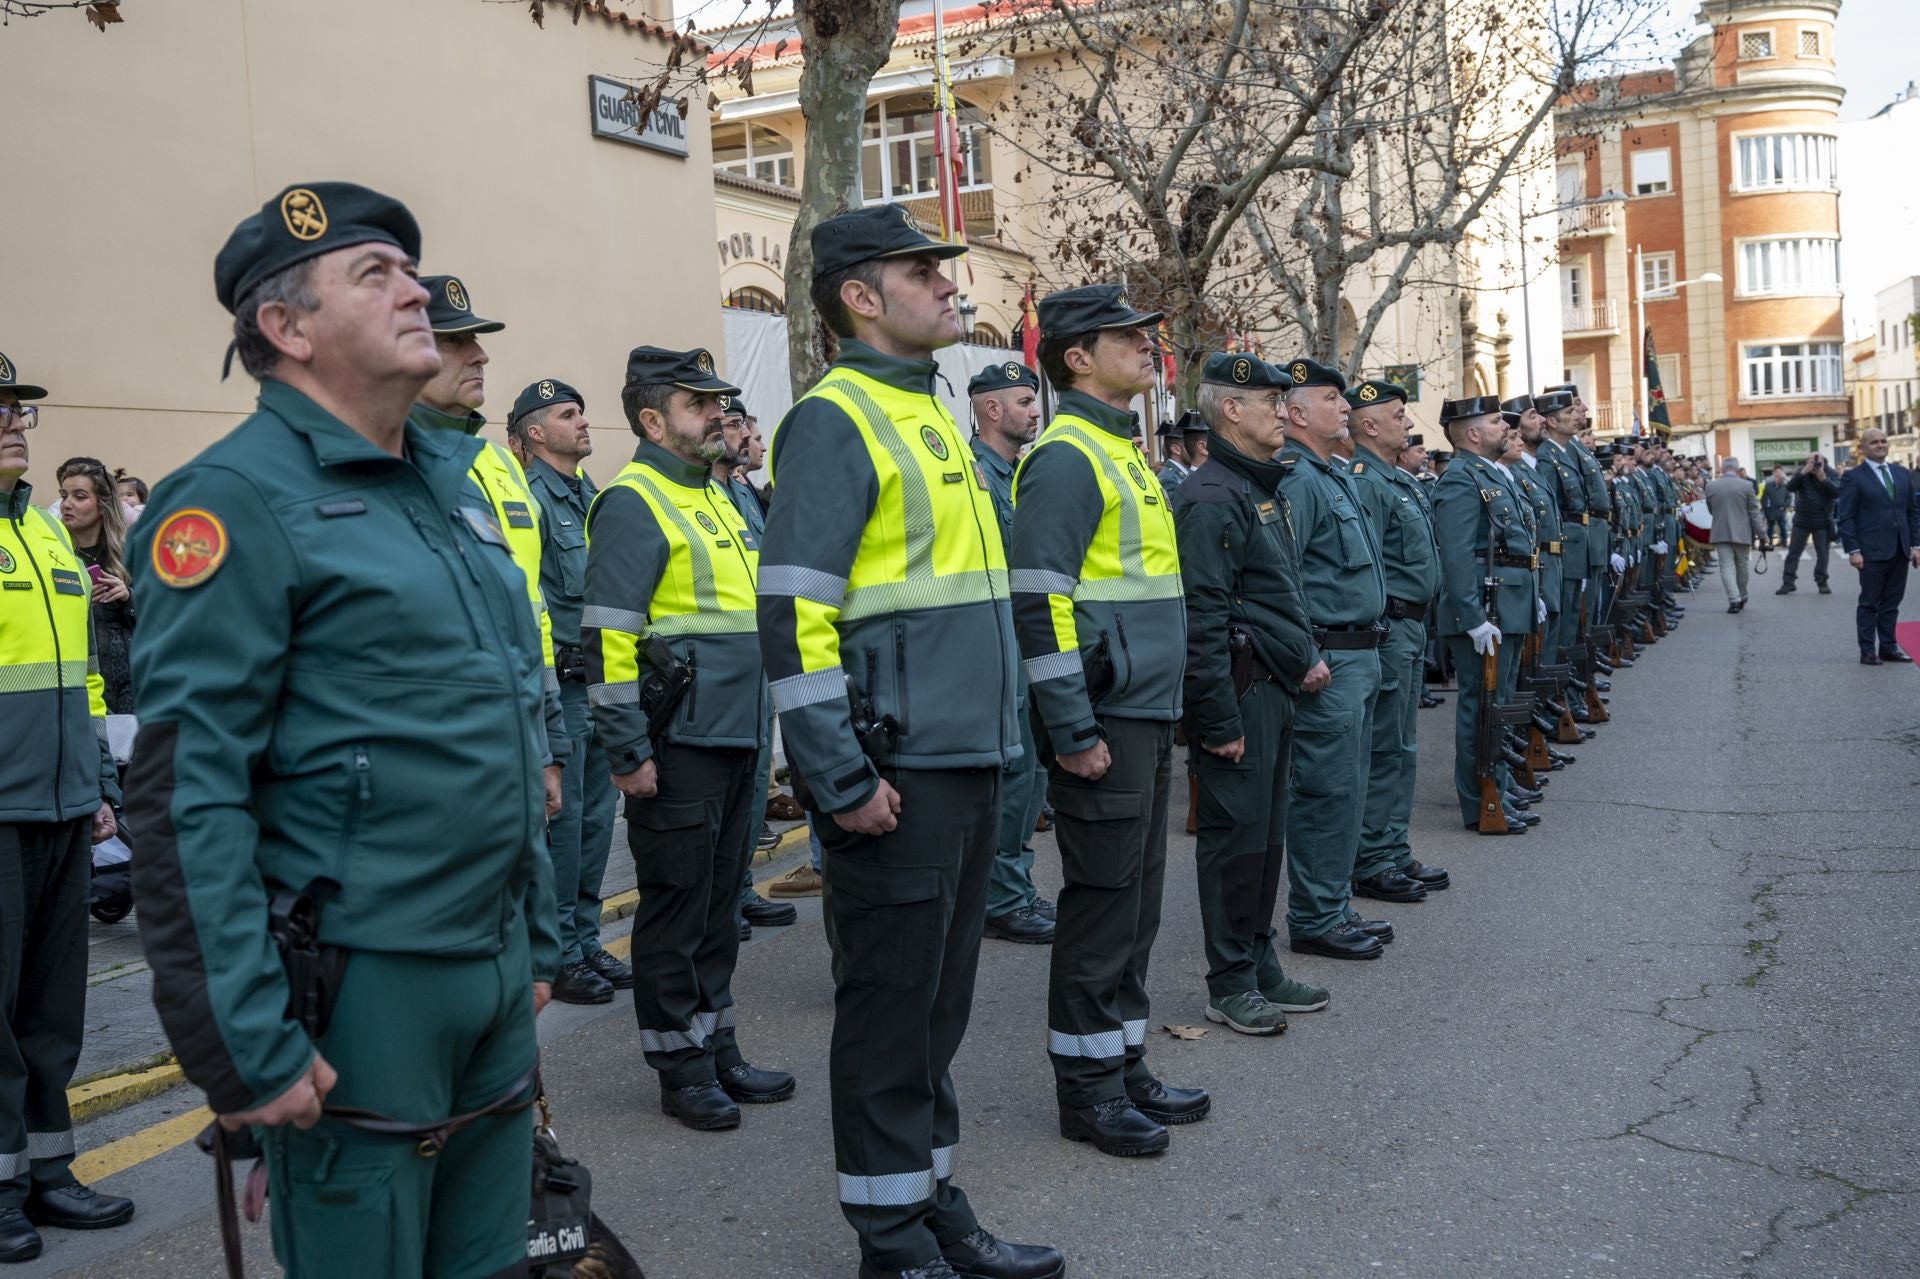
[{"xmin": 1281, "ymin": 442, "xmax": 1386, "ymax": 626}]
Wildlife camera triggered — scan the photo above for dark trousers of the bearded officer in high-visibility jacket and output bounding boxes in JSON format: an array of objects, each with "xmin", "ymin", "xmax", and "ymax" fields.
[{"xmin": 626, "ymin": 743, "xmax": 766, "ymax": 1089}]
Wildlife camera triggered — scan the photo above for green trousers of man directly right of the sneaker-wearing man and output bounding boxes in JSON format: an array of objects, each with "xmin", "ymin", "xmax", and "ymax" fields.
[{"xmin": 1286, "ymin": 649, "xmax": 1380, "ymax": 937}]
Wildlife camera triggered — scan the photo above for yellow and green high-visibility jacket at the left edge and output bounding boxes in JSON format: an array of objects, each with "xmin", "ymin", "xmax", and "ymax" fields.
[{"xmin": 0, "ymin": 480, "xmax": 121, "ymax": 822}]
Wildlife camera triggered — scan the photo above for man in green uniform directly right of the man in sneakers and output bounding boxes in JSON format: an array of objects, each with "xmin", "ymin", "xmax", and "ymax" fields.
[{"xmin": 1281, "ymin": 357, "xmax": 1394, "ymax": 960}]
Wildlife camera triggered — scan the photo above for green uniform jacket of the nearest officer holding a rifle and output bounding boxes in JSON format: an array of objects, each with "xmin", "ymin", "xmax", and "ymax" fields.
[{"xmin": 1434, "ymin": 449, "xmax": 1536, "ymax": 636}]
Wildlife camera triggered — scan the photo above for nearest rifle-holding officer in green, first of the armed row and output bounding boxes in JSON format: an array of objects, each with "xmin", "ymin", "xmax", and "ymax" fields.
[{"xmin": 1432, "ymin": 396, "xmax": 1540, "ymax": 833}]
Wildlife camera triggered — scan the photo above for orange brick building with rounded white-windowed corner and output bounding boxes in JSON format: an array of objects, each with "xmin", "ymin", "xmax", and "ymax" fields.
[{"xmin": 1559, "ymin": 0, "xmax": 1849, "ymax": 472}]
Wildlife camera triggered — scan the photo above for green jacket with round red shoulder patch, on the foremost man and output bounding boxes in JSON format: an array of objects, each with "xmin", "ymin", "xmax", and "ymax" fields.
[{"xmin": 127, "ymin": 380, "xmax": 561, "ymax": 1112}]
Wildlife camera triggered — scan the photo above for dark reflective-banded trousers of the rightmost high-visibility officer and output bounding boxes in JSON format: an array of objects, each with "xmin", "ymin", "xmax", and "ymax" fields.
[{"xmin": 1046, "ymin": 716, "xmax": 1173, "ymax": 1108}]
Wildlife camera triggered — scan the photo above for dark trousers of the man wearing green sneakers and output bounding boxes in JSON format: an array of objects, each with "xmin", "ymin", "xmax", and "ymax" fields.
[{"xmin": 1188, "ymin": 680, "xmax": 1294, "ymax": 997}]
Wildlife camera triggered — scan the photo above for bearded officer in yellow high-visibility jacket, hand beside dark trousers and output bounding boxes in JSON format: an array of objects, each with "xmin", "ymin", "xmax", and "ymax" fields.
[{"xmin": 580, "ymin": 346, "xmax": 795, "ymax": 1131}]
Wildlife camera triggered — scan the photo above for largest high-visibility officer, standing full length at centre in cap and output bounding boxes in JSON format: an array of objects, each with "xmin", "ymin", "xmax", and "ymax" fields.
[{"xmin": 758, "ymin": 204, "xmax": 1066, "ymax": 1279}]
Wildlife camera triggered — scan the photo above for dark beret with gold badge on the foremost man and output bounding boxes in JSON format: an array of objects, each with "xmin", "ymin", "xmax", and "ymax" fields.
[{"xmin": 213, "ymin": 182, "xmax": 420, "ymax": 311}]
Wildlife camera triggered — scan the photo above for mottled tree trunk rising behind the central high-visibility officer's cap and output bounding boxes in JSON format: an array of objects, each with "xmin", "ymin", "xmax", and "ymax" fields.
[{"xmin": 787, "ymin": 0, "xmax": 900, "ymax": 398}]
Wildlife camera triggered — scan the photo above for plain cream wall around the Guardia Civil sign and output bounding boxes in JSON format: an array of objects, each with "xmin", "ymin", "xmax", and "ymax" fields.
[{"xmin": 0, "ymin": 0, "xmax": 722, "ymax": 490}]
